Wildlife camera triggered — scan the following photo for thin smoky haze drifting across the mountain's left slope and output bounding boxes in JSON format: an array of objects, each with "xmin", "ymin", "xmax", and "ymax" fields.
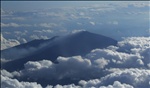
[{"xmin": 1, "ymin": 40, "xmax": 51, "ymax": 62}]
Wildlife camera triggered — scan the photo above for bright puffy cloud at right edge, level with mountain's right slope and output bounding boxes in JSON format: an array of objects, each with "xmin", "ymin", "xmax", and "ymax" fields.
[{"xmin": 118, "ymin": 37, "xmax": 150, "ymax": 66}]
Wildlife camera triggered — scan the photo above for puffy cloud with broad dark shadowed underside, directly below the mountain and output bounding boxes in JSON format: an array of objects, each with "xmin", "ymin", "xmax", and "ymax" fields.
[{"xmin": 21, "ymin": 56, "xmax": 103, "ymax": 80}]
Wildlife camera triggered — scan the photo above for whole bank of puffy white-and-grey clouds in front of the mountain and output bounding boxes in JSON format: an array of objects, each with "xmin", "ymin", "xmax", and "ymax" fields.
[{"xmin": 1, "ymin": 37, "xmax": 150, "ymax": 88}]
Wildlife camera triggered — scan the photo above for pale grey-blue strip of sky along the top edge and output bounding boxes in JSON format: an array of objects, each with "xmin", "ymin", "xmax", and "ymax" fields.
[{"xmin": 1, "ymin": 1, "xmax": 146, "ymax": 11}]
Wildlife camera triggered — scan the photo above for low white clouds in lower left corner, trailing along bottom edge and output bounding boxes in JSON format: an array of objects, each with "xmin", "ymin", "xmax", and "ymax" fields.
[{"xmin": 1, "ymin": 69, "xmax": 81, "ymax": 88}]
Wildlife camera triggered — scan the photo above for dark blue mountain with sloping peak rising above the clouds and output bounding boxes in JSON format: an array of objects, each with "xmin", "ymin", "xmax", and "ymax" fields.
[{"xmin": 1, "ymin": 31, "xmax": 117, "ymax": 71}]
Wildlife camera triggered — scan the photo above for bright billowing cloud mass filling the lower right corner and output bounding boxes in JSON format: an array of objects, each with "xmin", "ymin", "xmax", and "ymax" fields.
[{"xmin": 79, "ymin": 69, "xmax": 150, "ymax": 88}]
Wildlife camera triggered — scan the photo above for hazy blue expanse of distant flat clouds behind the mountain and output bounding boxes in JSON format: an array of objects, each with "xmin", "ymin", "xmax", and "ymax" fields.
[{"xmin": 1, "ymin": 2, "xmax": 149, "ymax": 50}]
